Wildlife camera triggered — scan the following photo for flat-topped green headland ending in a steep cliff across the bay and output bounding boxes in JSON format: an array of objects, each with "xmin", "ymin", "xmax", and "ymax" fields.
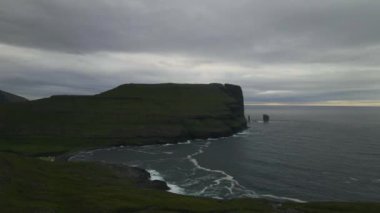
[{"xmin": 0, "ymin": 84, "xmax": 246, "ymax": 154}]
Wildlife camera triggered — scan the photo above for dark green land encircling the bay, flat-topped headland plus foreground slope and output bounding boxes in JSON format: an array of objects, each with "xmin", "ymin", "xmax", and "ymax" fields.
[{"xmin": 0, "ymin": 84, "xmax": 380, "ymax": 213}]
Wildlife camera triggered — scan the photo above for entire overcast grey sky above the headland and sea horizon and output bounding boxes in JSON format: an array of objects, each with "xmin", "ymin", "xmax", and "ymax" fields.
[{"xmin": 0, "ymin": 0, "xmax": 380, "ymax": 106}]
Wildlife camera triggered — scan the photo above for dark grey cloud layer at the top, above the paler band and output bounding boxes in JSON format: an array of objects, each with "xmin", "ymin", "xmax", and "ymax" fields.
[{"xmin": 0, "ymin": 0, "xmax": 380, "ymax": 62}]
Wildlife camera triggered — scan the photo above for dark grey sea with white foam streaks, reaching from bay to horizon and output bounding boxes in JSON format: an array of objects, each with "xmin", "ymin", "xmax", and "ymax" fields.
[{"xmin": 71, "ymin": 106, "xmax": 380, "ymax": 201}]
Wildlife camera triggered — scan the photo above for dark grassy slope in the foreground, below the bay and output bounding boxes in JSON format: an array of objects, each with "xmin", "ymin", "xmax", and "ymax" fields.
[{"xmin": 0, "ymin": 153, "xmax": 380, "ymax": 213}]
